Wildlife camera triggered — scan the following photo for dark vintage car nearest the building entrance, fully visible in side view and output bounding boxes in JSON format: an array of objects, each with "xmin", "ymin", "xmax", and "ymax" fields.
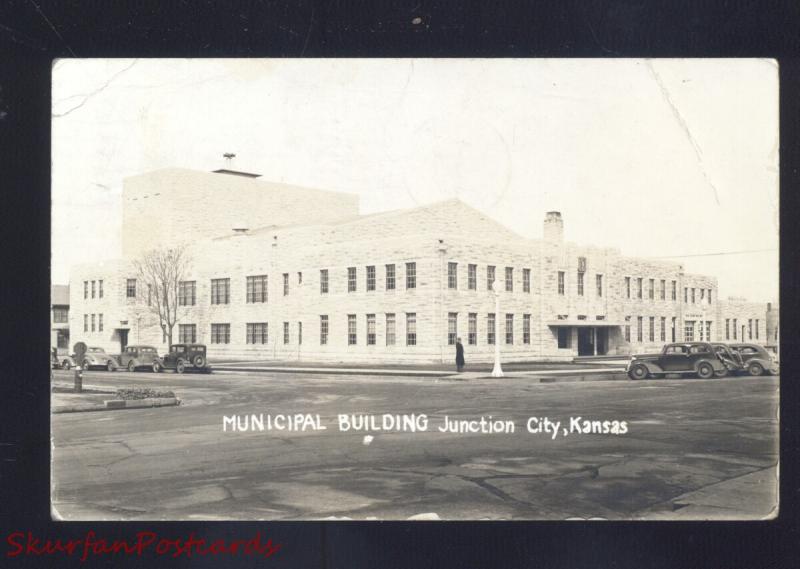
[{"xmin": 625, "ymin": 342, "xmax": 727, "ymax": 379}]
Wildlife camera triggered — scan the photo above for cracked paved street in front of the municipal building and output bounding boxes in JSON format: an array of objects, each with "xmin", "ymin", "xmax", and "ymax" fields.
[{"xmin": 52, "ymin": 371, "xmax": 778, "ymax": 520}]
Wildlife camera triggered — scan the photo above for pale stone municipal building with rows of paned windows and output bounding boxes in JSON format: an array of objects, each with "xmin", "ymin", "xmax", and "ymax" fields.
[{"xmin": 70, "ymin": 170, "xmax": 766, "ymax": 363}]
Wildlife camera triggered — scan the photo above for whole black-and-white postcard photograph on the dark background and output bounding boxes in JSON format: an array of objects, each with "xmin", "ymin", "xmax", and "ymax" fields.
[{"xmin": 48, "ymin": 57, "xmax": 781, "ymax": 523}]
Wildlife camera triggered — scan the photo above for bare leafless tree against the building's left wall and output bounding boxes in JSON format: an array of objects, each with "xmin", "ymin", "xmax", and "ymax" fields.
[{"xmin": 134, "ymin": 246, "xmax": 189, "ymax": 348}]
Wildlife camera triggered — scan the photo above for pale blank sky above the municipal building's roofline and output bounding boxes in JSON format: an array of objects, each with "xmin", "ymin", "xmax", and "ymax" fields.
[{"xmin": 52, "ymin": 59, "xmax": 779, "ymax": 301}]
